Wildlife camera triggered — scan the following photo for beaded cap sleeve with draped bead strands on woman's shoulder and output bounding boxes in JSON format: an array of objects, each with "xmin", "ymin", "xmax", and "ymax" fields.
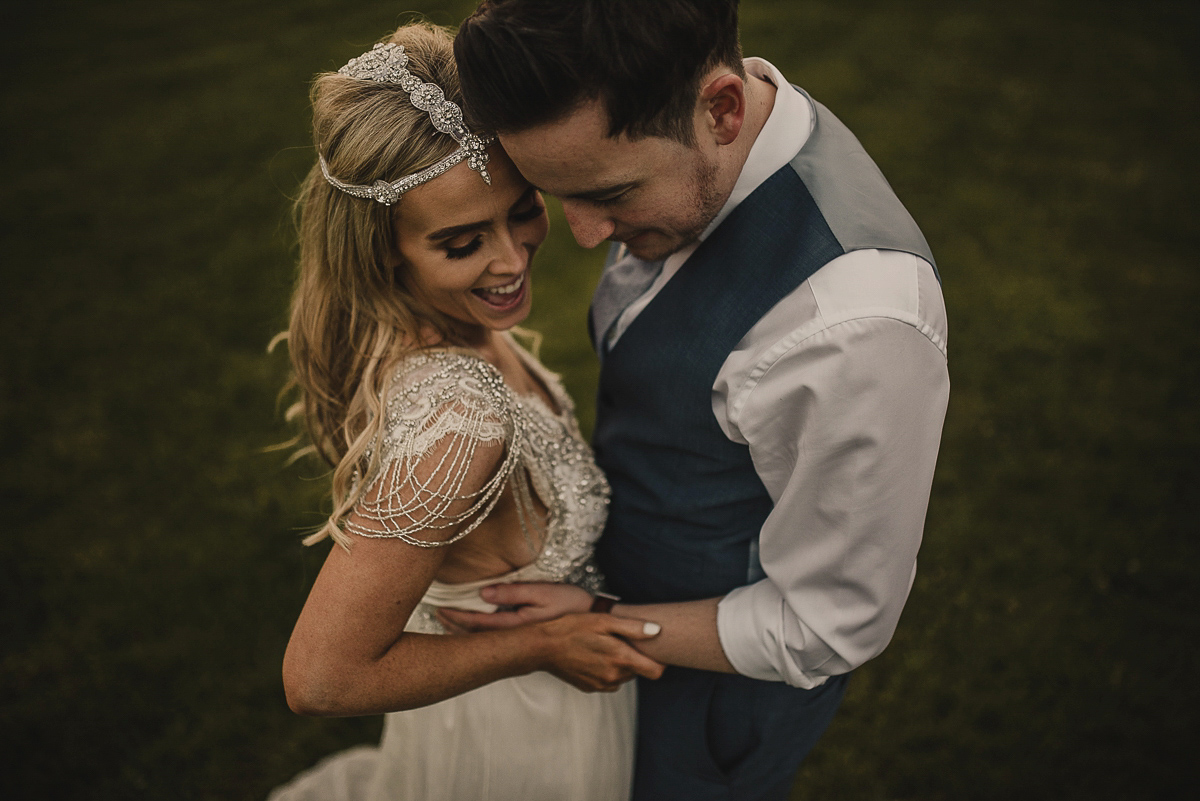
[{"xmin": 344, "ymin": 351, "xmax": 526, "ymax": 548}]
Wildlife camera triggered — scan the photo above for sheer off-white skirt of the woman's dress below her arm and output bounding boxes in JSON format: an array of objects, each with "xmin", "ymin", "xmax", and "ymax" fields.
[{"xmin": 269, "ymin": 673, "xmax": 636, "ymax": 801}]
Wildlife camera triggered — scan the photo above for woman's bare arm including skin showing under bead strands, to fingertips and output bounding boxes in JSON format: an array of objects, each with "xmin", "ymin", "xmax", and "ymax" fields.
[{"xmin": 283, "ymin": 406, "xmax": 662, "ymax": 716}]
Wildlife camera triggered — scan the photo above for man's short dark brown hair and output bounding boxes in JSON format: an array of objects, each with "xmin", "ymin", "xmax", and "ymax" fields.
[{"xmin": 455, "ymin": 0, "xmax": 744, "ymax": 145}]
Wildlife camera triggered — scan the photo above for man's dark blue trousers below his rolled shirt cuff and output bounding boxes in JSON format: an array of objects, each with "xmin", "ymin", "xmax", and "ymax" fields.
[{"xmin": 632, "ymin": 667, "xmax": 848, "ymax": 801}]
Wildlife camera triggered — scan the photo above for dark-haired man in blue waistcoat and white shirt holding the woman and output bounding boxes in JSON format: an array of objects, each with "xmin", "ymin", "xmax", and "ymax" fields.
[{"xmin": 455, "ymin": 0, "xmax": 949, "ymax": 801}]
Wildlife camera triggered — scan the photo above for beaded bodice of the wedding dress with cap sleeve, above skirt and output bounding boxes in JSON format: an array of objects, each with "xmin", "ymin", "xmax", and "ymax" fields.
[{"xmin": 346, "ymin": 343, "xmax": 608, "ymax": 633}]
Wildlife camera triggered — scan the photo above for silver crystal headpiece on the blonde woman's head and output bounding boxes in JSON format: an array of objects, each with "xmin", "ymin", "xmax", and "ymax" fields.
[{"xmin": 318, "ymin": 42, "xmax": 494, "ymax": 206}]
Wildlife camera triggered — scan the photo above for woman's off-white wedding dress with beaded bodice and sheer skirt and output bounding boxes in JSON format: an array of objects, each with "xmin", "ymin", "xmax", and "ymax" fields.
[{"xmin": 269, "ymin": 339, "xmax": 636, "ymax": 801}]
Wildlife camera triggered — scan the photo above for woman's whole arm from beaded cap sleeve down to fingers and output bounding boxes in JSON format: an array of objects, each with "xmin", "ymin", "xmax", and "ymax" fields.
[{"xmin": 283, "ymin": 355, "xmax": 661, "ymax": 716}]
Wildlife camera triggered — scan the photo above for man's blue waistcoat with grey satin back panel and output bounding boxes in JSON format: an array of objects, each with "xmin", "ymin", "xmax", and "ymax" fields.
[{"xmin": 594, "ymin": 90, "xmax": 934, "ymax": 603}]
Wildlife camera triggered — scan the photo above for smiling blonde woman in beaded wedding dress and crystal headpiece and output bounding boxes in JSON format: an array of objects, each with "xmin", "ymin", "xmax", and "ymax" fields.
[{"xmin": 271, "ymin": 24, "xmax": 661, "ymax": 801}]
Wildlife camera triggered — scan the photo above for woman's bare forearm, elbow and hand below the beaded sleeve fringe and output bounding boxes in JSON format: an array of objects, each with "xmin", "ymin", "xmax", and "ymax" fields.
[{"xmin": 283, "ymin": 537, "xmax": 662, "ymax": 716}]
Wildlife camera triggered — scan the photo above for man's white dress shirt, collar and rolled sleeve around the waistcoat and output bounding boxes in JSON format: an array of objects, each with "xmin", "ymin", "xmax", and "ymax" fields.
[{"xmin": 608, "ymin": 59, "xmax": 949, "ymax": 687}]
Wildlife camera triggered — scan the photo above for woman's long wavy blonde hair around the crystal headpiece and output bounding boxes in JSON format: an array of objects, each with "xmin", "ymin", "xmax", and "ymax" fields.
[{"xmin": 272, "ymin": 22, "xmax": 492, "ymax": 548}]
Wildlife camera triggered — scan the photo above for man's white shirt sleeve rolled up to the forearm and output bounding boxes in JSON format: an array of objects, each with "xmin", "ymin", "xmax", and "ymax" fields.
[{"xmin": 718, "ymin": 312, "xmax": 949, "ymax": 687}]
